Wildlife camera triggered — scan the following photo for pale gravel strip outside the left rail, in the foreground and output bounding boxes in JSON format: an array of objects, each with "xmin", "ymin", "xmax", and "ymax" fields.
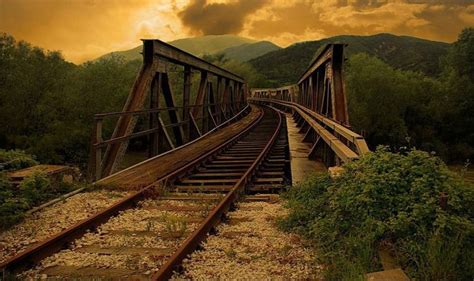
[{"xmin": 0, "ymin": 190, "xmax": 129, "ymax": 262}]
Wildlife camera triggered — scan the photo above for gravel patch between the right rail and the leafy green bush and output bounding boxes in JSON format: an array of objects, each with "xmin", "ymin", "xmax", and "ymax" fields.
[{"xmin": 173, "ymin": 197, "xmax": 322, "ymax": 280}]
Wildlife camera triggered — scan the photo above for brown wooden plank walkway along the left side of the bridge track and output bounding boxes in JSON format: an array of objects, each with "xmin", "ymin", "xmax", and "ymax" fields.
[{"xmin": 97, "ymin": 106, "xmax": 260, "ymax": 188}]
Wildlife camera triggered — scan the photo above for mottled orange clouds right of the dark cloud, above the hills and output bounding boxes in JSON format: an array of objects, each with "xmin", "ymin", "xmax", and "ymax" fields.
[{"xmin": 244, "ymin": 0, "xmax": 474, "ymax": 46}]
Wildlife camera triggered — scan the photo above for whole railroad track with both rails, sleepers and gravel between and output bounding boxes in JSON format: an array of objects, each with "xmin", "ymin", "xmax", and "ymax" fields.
[{"xmin": 0, "ymin": 104, "xmax": 291, "ymax": 280}]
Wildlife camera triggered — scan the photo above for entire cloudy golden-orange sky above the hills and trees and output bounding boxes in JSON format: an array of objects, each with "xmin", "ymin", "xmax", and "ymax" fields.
[{"xmin": 0, "ymin": 0, "xmax": 474, "ymax": 63}]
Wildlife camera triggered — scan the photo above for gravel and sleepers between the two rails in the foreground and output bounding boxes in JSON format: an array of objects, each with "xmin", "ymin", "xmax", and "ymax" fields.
[{"xmin": 19, "ymin": 199, "xmax": 215, "ymax": 279}]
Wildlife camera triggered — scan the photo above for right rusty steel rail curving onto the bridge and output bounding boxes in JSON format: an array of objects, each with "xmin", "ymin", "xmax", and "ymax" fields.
[{"xmin": 152, "ymin": 104, "xmax": 282, "ymax": 280}]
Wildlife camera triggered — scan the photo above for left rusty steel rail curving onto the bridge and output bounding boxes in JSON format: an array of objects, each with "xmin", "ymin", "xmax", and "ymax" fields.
[{"xmin": 0, "ymin": 104, "xmax": 263, "ymax": 273}]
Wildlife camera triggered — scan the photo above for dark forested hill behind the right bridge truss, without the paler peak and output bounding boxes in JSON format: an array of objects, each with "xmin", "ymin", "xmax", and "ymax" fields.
[{"xmin": 250, "ymin": 34, "xmax": 449, "ymax": 87}]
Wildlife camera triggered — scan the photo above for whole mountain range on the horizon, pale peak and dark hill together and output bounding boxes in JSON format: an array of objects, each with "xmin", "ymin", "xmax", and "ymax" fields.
[{"xmin": 96, "ymin": 33, "xmax": 450, "ymax": 86}]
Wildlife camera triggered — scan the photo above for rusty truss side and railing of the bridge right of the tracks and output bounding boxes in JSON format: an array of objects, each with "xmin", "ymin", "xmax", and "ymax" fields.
[{"xmin": 251, "ymin": 44, "xmax": 369, "ymax": 167}]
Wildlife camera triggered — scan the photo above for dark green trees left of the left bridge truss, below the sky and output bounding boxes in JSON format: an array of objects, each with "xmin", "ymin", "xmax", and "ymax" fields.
[{"xmin": 0, "ymin": 34, "xmax": 140, "ymax": 165}]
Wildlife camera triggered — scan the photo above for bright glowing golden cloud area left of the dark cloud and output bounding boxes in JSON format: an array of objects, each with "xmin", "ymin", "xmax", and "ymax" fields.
[{"xmin": 0, "ymin": 0, "xmax": 186, "ymax": 63}]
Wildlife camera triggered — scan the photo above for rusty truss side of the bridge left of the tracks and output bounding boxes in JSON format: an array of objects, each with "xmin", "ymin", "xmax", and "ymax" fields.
[{"xmin": 89, "ymin": 40, "xmax": 247, "ymax": 180}]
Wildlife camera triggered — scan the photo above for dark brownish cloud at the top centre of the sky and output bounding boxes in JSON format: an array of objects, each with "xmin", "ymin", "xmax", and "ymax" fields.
[{"xmin": 178, "ymin": 0, "xmax": 268, "ymax": 35}]
